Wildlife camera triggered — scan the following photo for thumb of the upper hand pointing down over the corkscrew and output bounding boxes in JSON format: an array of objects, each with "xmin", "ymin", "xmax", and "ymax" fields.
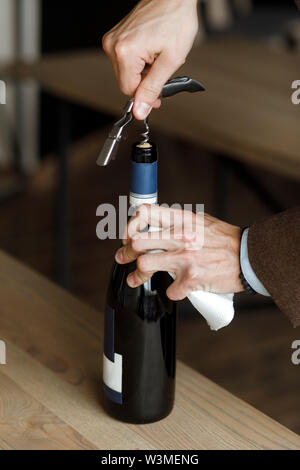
[{"xmin": 133, "ymin": 52, "xmax": 177, "ymax": 120}]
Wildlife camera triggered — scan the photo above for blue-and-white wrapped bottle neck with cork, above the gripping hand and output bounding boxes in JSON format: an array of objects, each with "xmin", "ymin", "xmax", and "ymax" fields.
[{"xmin": 130, "ymin": 143, "xmax": 158, "ymax": 207}]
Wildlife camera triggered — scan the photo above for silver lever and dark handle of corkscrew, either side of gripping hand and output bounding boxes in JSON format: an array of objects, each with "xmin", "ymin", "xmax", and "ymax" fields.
[{"xmin": 97, "ymin": 77, "xmax": 205, "ymax": 166}]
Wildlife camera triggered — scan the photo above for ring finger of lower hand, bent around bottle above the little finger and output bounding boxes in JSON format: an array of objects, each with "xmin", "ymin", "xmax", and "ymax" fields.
[{"xmin": 127, "ymin": 252, "xmax": 177, "ymax": 287}]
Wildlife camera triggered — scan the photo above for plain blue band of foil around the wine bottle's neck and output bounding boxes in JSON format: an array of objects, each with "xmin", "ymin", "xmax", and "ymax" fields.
[{"xmin": 131, "ymin": 162, "xmax": 157, "ymax": 194}]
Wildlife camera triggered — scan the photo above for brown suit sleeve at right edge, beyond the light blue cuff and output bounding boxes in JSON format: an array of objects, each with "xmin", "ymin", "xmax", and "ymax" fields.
[{"xmin": 248, "ymin": 207, "xmax": 300, "ymax": 327}]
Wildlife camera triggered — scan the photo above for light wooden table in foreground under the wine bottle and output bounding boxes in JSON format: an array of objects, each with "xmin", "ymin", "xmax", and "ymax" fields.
[{"xmin": 0, "ymin": 252, "xmax": 300, "ymax": 450}]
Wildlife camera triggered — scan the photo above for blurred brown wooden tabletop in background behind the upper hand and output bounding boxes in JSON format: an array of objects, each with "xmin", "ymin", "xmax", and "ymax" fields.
[{"xmin": 0, "ymin": 38, "xmax": 300, "ymax": 179}]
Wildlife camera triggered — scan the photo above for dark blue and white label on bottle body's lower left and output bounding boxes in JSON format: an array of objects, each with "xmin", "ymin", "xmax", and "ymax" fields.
[{"xmin": 103, "ymin": 305, "xmax": 123, "ymax": 404}]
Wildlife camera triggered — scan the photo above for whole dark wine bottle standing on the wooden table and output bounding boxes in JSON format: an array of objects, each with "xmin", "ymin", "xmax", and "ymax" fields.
[{"xmin": 103, "ymin": 143, "xmax": 177, "ymax": 424}]
